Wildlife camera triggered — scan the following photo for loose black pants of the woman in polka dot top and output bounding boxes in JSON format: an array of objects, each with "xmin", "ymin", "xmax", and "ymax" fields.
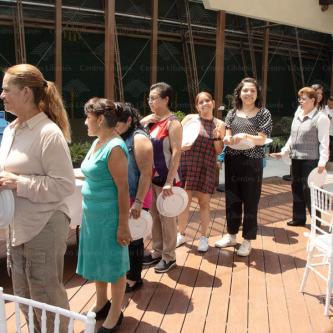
[{"xmin": 225, "ymin": 154, "xmax": 263, "ymax": 240}]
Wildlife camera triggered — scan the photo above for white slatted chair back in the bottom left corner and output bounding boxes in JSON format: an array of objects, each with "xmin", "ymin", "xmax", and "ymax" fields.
[{"xmin": 0, "ymin": 287, "xmax": 96, "ymax": 333}]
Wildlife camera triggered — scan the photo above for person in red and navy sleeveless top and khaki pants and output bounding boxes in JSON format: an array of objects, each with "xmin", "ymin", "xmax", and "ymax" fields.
[{"xmin": 141, "ymin": 82, "xmax": 182, "ymax": 273}]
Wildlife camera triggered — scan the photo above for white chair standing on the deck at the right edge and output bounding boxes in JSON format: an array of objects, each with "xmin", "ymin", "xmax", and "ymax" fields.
[{"xmin": 300, "ymin": 184, "xmax": 333, "ymax": 316}]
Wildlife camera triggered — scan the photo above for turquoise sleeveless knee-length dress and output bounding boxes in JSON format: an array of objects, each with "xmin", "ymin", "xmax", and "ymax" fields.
[{"xmin": 76, "ymin": 138, "xmax": 129, "ymax": 282}]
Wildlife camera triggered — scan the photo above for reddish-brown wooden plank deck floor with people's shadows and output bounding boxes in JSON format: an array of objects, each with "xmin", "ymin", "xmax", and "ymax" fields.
[{"xmin": 0, "ymin": 178, "xmax": 333, "ymax": 333}]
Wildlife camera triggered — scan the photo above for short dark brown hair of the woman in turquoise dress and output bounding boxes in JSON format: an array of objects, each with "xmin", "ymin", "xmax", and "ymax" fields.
[{"xmin": 84, "ymin": 97, "xmax": 121, "ymax": 128}]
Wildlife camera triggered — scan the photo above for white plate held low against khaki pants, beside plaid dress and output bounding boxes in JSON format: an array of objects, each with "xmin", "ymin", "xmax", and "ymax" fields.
[{"xmin": 156, "ymin": 186, "xmax": 188, "ymax": 217}]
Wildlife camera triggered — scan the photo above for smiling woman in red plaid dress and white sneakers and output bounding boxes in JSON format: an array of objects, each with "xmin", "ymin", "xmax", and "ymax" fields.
[{"xmin": 177, "ymin": 91, "xmax": 225, "ymax": 252}]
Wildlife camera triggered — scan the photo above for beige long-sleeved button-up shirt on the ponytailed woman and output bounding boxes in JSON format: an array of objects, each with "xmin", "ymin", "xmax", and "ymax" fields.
[{"xmin": 0, "ymin": 112, "xmax": 75, "ymax": 246}]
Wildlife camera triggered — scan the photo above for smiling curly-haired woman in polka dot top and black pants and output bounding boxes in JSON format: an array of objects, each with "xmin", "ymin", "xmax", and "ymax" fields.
[{"xmin": 215, "ymin": 78, "xmax": 272, "ymax": 256}]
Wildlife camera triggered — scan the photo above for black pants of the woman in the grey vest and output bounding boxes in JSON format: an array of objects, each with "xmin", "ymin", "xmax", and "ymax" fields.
[{"xmin": 291, "ymin": 159, "xmax": 318, "ymax": 223}]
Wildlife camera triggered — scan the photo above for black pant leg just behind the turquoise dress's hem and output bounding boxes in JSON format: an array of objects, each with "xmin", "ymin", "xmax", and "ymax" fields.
[{"xmin": 127, "ymin": 238, "xmax": 144, "ymax": 282}]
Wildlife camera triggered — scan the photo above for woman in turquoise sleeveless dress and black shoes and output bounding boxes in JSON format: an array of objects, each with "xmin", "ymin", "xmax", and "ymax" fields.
[{"xmin": 77, "ymin": 97, "xmax": 131, "ymax": 333}]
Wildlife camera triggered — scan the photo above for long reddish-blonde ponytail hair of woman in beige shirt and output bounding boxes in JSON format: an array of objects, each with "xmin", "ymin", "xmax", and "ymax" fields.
[{"xmin": 4, "ymin": 64, "xmax": 71, "ymax": 142}]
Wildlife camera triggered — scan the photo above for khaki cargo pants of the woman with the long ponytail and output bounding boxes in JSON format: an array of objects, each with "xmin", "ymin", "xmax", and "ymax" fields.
[{"xmin": 10, "ymin": 211, "xmax": 69, "ymax": 333}]
